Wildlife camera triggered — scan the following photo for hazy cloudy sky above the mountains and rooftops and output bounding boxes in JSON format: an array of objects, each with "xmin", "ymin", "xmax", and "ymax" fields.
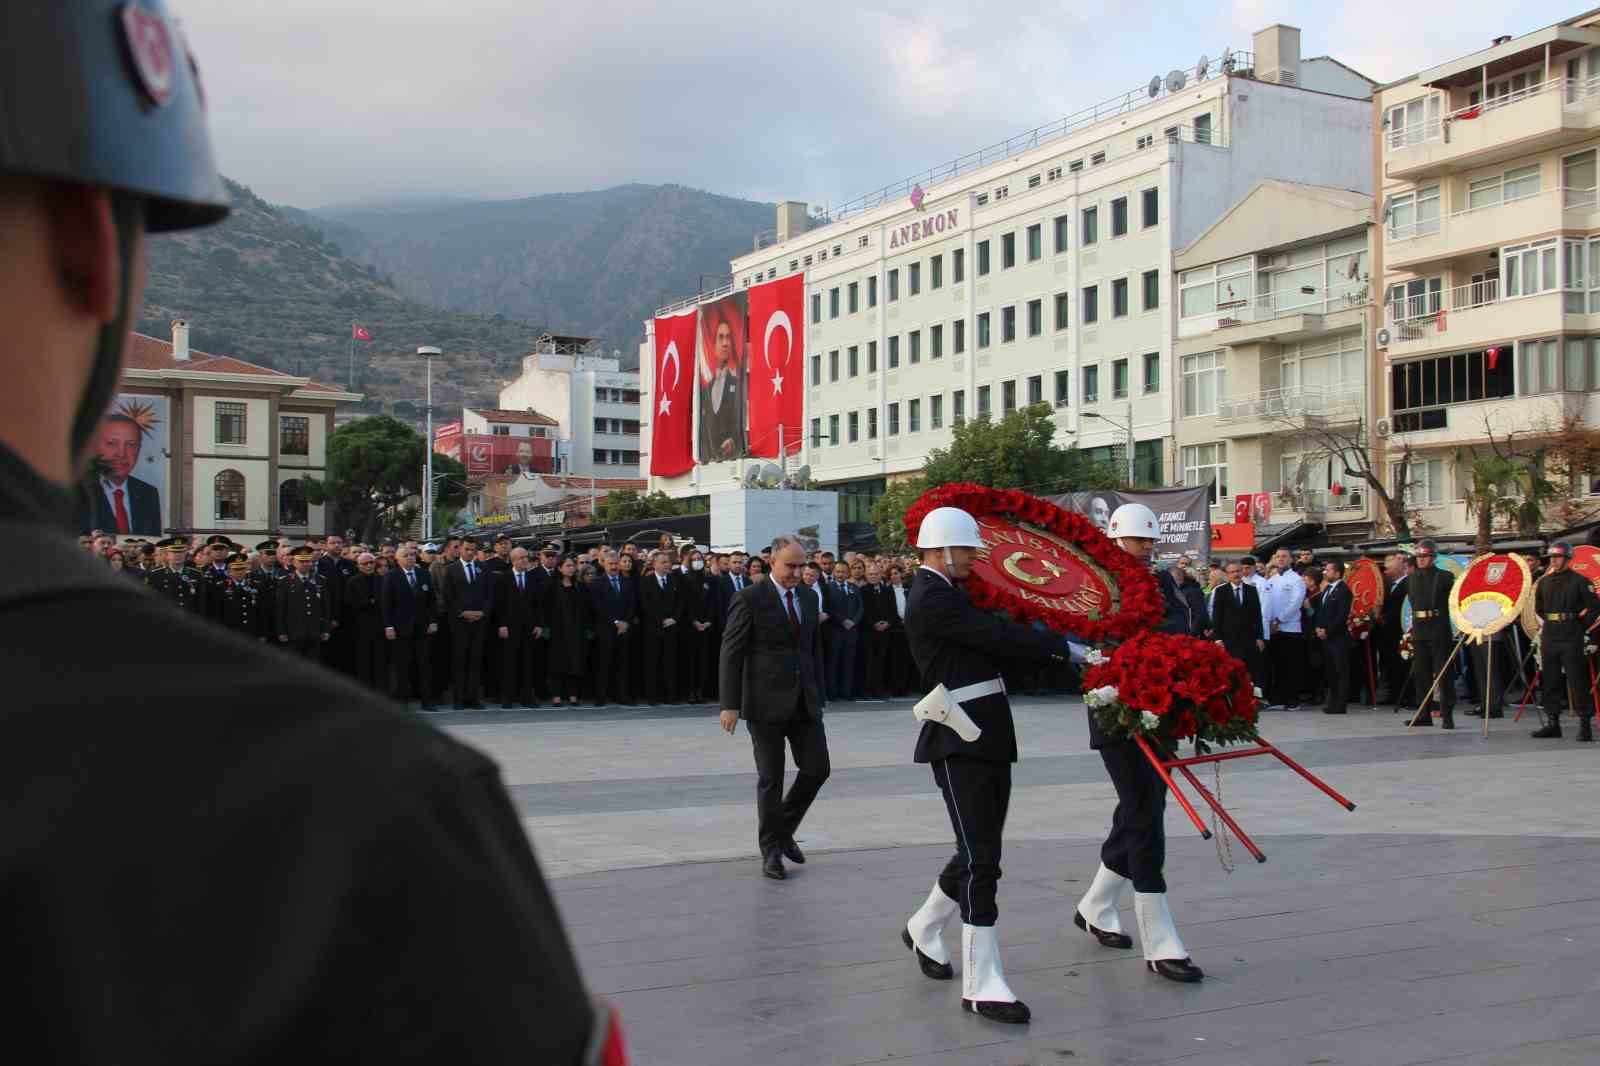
[{"xmin": 181, "ymin": 0, "xmax": 1584, "ymax": 206}]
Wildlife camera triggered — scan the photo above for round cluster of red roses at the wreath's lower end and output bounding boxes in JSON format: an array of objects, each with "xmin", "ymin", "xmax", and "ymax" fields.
[{"xmin": 1083, "ymin": 632, "xmax": 1258, "ymax": 744}]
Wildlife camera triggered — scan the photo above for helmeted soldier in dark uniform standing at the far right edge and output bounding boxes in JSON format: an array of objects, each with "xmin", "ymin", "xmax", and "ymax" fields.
[{"xmin": 1533, "ymin": 541, "xmax": 1600, "ymax": 743}]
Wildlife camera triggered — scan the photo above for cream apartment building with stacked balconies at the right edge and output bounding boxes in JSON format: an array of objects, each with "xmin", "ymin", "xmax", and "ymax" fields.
[{"xmin": 1374, "ymin": 11, "xmax": 1600, "ymax": 533}]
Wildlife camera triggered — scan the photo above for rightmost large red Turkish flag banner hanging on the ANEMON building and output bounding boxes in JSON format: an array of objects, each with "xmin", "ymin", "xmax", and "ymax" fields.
[{"xmin": 749, "ymin": 274, "xmax": 805, "ymax": 459}]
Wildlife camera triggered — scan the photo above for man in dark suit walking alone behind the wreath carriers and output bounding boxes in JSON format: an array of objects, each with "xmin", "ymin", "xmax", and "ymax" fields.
[{"xmin": 723, "ymin": 536, "xmax": 829, "ymax": 880}]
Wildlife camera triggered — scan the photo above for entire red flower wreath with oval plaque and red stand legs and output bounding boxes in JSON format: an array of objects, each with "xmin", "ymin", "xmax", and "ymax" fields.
[{"xmin": 906, "ymin": 483, "xmax": 1355, "ymax": 863}]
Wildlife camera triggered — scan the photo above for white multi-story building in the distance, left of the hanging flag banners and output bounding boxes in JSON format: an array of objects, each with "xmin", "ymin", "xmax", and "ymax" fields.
[{"xmin": 499, "ymin": 333, "xmax": 640, "ymax": 479}]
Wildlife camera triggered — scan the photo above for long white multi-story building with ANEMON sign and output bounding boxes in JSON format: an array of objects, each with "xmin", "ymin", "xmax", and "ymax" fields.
[{"xmin": 640, "ymin": 26, "xmax": 1373, "ymax": 522}]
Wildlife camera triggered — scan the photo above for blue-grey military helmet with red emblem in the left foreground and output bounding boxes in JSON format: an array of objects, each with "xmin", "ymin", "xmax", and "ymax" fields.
[{"xmin": 0, "ymin": 0, "xmax": 229, "ymax": 230}]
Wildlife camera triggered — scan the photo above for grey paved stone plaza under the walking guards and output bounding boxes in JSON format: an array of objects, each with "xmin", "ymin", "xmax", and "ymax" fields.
[{"xmin": 440, "ymin": 699, "xmax": 1600, "ymax": 1066}]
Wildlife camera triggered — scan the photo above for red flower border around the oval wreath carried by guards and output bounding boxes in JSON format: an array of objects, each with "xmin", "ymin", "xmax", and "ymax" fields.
[{"xmin": 906, "ymin": 482, "xmax": 1166, "ymax": 643}]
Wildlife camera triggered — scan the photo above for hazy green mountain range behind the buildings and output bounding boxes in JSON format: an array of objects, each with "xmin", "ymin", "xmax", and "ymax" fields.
[{"xmin": 138, "ymin": 182, "xmax": 773, "ymax": 405}]
